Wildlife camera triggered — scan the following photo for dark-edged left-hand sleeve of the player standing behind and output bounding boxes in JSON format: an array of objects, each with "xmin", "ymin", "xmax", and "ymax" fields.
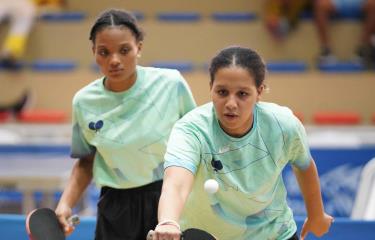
[{"xmin": 70, "ymin": 101, "xmax": 95, "ymax": 158}]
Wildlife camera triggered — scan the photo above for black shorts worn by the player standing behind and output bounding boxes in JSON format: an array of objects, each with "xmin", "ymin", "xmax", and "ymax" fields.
[{"xmin": 95, "ymin": 181, "xmax": 162, "ymax": 240}]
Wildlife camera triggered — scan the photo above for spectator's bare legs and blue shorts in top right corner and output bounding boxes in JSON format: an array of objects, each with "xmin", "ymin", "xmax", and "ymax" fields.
[{"xmin": 314, "ymin": 0, "xmax": 375, "ymax": 66}]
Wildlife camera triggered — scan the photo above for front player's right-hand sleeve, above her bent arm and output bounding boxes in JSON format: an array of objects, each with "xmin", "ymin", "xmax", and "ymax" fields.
[{"xmin": 288, "ymin": 116, "xmax": 312, "ymax": 169}]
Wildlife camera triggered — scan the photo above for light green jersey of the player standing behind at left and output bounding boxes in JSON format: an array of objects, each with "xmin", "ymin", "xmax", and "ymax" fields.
[{"xmin": 71, "ymin": 66, "xmax": 196, "ymax": 188}]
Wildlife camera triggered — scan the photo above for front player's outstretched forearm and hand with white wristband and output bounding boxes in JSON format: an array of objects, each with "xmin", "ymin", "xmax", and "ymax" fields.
[{"xmin": 153, "ymin": 166, "xmax": 194, "ymax": 240}]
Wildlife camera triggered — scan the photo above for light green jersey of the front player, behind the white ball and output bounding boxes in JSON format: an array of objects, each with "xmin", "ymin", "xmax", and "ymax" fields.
[{"xmin": 164, "ymin": 102, "xmax": 311, "ymax": 240}]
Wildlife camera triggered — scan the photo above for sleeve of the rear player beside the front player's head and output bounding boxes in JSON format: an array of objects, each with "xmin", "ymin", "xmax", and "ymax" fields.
[{"xmin": 178, "ymin": 74, "xmax": 197, "ymax": 117}]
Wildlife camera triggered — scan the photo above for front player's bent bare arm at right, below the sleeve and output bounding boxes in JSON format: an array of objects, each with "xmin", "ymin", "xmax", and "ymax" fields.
[{"xmin": 293, "ymin": 159, "xmax": 333, "ymax": 240}]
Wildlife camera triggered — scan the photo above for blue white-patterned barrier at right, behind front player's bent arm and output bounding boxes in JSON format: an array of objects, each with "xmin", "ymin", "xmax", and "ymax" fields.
[{"xmin": 283, "ymin": 146, "xmax": 375, "ymax": 218}]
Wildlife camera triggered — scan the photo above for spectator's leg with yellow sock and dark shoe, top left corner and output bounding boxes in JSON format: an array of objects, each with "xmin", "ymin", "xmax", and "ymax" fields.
[{"xmin": 0, "ymin": 0, "xmax": 36, "ymax": 70}]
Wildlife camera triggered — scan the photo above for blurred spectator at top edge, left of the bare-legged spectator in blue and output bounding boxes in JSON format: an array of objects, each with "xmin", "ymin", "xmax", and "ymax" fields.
[{"xmin": 265, "ymin": 0, "xmax": 311, "ymax": 40}]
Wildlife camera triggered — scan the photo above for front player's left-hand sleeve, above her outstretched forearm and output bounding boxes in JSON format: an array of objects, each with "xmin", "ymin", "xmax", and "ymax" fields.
[{"xmin": 164, "ymin": 122, "xmax": 201, "ymax": 174}]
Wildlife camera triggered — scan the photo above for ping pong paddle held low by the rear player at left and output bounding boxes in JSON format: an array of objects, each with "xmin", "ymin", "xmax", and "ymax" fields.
[{"xmin": 26, "ymin": 208, "xmax": 79, "ymax": 240}]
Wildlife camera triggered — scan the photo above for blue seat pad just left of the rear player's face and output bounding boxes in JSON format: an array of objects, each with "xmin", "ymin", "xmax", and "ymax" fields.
[{"xmin": 31, "ymin": 60, "xmax": 77, "ymax": 72}]
